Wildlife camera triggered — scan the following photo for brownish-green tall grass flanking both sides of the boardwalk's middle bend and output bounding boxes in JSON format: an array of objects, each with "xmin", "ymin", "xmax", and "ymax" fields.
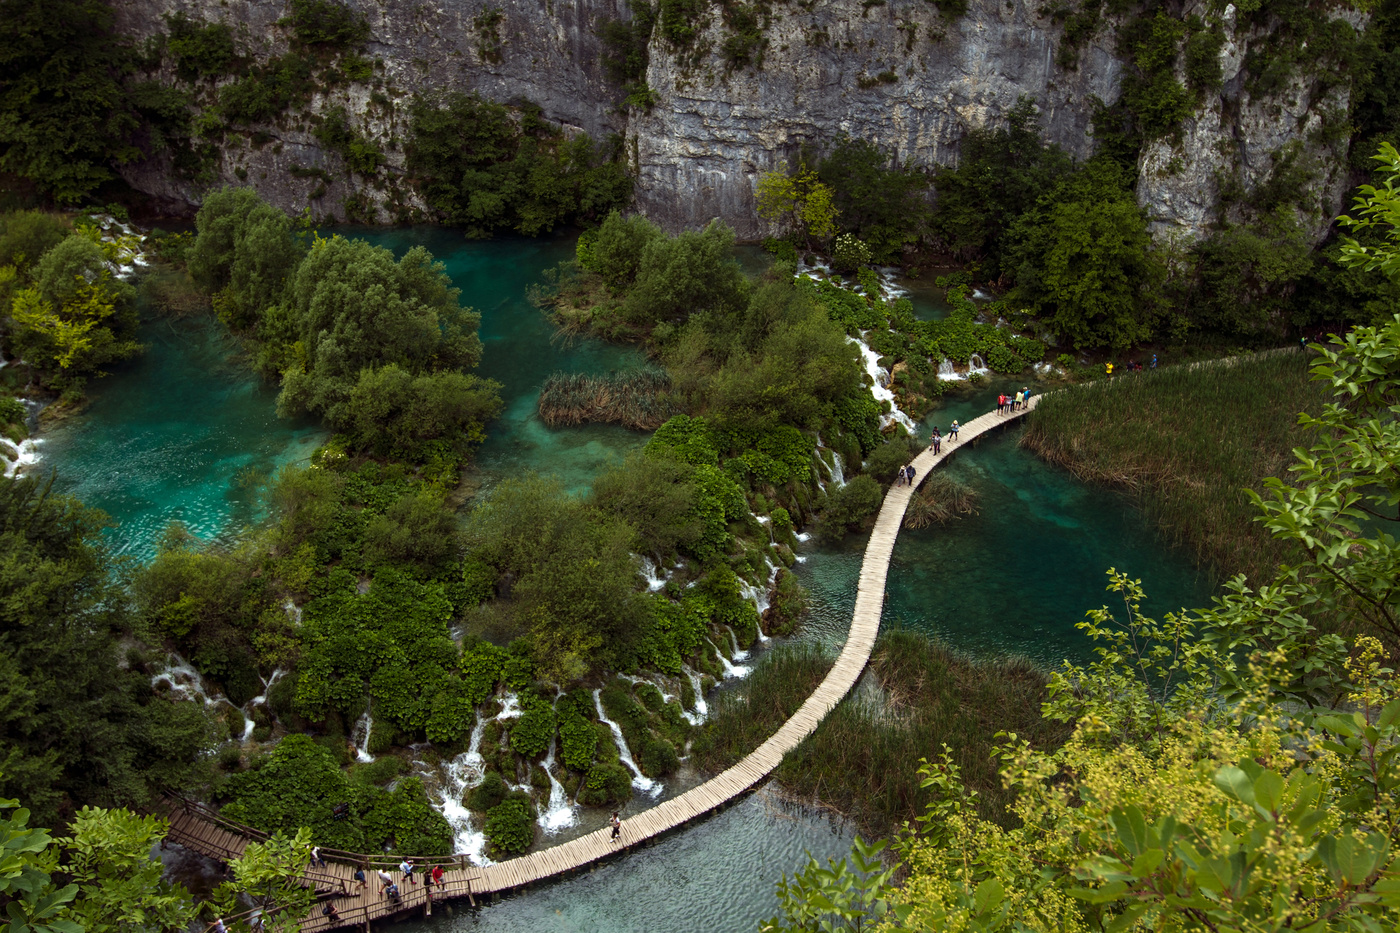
[{"xmin": 697, "ymin": 630, "xmax": 1070, "ymax": 835}]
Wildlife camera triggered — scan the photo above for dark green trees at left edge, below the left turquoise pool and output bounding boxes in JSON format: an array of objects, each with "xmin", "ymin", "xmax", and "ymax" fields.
[{"xmin": 0, "ymin": 479, "xmax": 210, "ymax": 825}]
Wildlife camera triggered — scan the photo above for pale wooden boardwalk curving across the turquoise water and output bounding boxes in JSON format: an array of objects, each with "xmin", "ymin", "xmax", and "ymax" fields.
[{"xmin": 169, "ymin": 395, "xmax": 1040, "ymax": 933}]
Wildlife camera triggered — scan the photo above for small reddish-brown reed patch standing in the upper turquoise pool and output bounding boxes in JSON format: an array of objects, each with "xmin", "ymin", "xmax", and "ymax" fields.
[{"xmin": 539, "ymin": 370, "xmax": 678, "ymax": 430}]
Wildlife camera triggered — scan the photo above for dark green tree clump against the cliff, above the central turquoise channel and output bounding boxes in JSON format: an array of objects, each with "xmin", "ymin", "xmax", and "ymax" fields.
[{"xmin": 406, "ymin": 94, "xmax": 631, "ymax": 237}]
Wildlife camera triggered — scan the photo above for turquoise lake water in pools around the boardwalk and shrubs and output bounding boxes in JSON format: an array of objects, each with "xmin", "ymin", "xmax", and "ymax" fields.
[{"xmin": 41, "ymin": 227, "xmax": 1211, "ymax": 933}]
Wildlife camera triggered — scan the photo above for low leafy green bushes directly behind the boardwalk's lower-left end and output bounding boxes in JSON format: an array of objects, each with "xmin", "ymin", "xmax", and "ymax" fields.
[{"xmin": 220, "ymin": 735, "xmax": 452, "ymax": 856}]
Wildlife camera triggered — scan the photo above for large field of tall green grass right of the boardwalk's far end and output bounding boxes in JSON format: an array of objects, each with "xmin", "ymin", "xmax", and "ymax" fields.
[{"xmin": 1021, "ymin": 353, "xmax": 1327, "ymax": 583}]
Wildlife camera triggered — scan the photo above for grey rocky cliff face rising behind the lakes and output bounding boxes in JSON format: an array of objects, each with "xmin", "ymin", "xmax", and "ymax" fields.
[{"xmin": 118, "ymin": 0, "xmax": 1359, "ymax": 238}]
